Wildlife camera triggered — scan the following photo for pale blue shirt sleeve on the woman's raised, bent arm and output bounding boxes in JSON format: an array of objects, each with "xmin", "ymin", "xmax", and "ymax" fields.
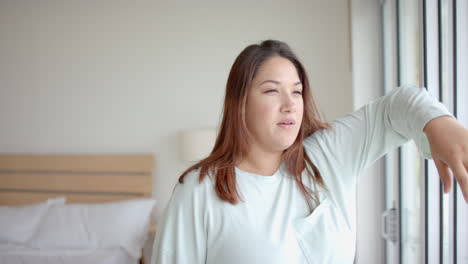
[{"xmin": 304, "ymin": 86, "xmax": 452, "ymax": 185}]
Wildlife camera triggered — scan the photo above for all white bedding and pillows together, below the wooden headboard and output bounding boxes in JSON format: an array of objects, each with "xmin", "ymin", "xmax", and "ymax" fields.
[{"xmin": 0, "ymin": 198, "xmax": 155, "ymax": 264}]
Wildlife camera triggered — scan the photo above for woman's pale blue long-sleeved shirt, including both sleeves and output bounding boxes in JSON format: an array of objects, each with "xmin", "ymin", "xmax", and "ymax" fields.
[{"xmin": 152, "ymin": 87, "xmax": 451, "ymax": 264}]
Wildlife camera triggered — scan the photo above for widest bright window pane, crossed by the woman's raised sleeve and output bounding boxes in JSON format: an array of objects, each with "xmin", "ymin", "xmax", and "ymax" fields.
[{"xmin": 399, "ymin": 0, "xmax": 424, "ymax": 263}]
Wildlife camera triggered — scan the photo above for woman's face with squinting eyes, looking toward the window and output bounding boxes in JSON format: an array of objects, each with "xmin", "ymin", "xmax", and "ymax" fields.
[{"xmin": 246, "ymin": 56, "xmax": 304, "ymax": 152}]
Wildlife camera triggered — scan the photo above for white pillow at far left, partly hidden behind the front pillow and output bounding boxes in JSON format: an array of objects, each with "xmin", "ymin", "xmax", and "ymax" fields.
[{"xmin": 0, "ymin": 197, "xmax": 66, "ymax": 244}]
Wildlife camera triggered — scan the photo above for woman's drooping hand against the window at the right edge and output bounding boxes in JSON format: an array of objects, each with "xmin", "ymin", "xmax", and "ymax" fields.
[{"xmin": 424, "ymin": 116, "xmax": 468, "ymax": 203}]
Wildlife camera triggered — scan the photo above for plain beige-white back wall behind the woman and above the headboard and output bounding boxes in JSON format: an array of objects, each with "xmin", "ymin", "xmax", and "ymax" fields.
[{"xmin": 0, "ymin": 0, "xmax": 353, "ymax": 223}]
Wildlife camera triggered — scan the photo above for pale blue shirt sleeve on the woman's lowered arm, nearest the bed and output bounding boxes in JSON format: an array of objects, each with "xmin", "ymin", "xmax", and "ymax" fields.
[{"xmin": 151, "ymin": 173, "xmax": 206, "ymax": 264}]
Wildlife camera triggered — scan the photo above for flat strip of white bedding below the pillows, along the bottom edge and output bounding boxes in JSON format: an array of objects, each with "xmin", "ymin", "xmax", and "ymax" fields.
[{"xmin": 0, "ymin": 246, "xmax": 138, "ymax": 264}]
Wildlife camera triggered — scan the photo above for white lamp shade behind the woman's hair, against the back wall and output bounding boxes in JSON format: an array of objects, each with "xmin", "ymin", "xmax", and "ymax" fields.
[{"xmin": 180, "ymin": 128, "xmax": 216, "ymax": 162}]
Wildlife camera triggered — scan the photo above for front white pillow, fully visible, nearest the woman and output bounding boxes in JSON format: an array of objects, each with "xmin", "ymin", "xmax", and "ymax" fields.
[{"xmin": 30, "ymin": 199, "xmax": 156, "ymax": 259}]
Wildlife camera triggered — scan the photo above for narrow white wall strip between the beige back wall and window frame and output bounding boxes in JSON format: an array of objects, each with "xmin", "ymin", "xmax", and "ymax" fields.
[{"xmin": 351, "ymin": 0, "xmax": 385, "ymax": 264}]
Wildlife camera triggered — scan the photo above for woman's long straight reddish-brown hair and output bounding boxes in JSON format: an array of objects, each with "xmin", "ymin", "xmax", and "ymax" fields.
[{"xmin": 179, "ymin": 40, "xmax": 330, "ymax": 209}]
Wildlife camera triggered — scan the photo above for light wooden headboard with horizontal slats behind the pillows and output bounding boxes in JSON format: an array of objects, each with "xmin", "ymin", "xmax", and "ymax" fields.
[{"xmin": 0, "ymin": 154, "xmax": 154, "ymax": 205}]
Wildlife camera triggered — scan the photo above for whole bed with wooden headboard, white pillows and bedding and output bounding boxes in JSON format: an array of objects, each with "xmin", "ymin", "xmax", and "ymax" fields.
[{"xmin": 0, "ymin": 154, "xmax": 156, "ymax": 264}]
